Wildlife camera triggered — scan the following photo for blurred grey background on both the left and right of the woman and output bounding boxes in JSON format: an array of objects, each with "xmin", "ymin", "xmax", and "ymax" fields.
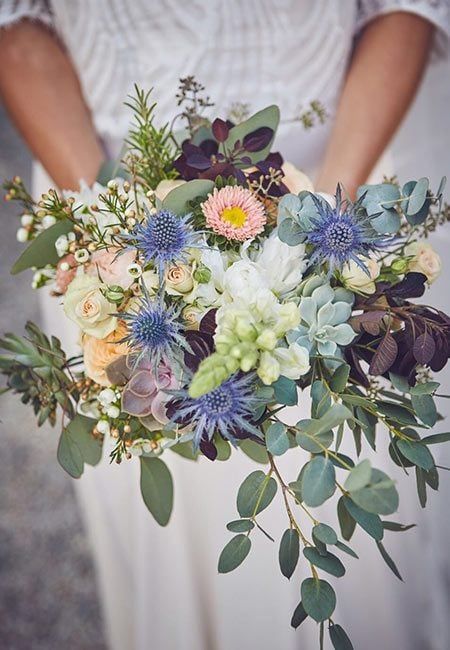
[{"xmin": 0, "ymin": 57, "xmax": 450, "ymax": 650}]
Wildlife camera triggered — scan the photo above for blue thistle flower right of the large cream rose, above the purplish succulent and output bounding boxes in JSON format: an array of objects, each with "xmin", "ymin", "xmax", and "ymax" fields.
[{"xmin": 119, "ymin": 287, "xmax": 187, "ymax": 371}]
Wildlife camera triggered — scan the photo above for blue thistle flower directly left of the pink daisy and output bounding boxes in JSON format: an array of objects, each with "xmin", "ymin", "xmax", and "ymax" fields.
[{"xmin": 128, "ymin": 209, "xmax": 196, "ymax": 277}]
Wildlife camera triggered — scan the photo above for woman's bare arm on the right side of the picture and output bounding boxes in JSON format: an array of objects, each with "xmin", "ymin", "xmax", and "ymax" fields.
[{"xmin": 317, "ymin": 12, "xmax": 433, "ymax": 196}]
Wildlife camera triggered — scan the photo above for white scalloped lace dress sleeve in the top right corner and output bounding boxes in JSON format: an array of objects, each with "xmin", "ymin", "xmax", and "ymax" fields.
[{"xmin": 357, "ymin": 0, "xmax": 450, "ymax": 58}]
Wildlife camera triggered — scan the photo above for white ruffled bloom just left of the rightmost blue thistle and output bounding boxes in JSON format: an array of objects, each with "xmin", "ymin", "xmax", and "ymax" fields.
[{"xmin": 255, "ymin": 232, "xmax": 307, "ymax": 295}]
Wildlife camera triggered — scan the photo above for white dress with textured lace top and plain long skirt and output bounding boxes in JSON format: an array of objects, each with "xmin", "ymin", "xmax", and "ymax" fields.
[{"xmin": 0, "ymin": 0, "xmax": 449, "ymax": 650}]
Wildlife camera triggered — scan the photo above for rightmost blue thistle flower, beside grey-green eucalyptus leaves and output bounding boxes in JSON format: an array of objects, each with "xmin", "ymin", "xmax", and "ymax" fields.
[{"xmin": 306, "ymin": 185, "xmax": 393, "ymax": 275}]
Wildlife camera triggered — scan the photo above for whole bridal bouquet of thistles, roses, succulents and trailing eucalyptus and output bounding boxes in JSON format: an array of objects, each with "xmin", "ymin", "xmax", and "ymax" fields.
[{"xmin": 0, "ymin": 78, "xmax": 450, "ymax": 649}]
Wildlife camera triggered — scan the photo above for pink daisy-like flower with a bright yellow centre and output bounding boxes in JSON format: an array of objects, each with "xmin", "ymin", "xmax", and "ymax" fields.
[{"xmin": 202, "ymin": 185, "xmax": 266, "ymax": 241}]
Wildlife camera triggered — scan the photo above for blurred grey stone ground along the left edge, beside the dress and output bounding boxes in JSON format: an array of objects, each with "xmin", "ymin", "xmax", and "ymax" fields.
[{"xmin": 0, "ymin": 107, "xmax": 106, "ymax": 650}]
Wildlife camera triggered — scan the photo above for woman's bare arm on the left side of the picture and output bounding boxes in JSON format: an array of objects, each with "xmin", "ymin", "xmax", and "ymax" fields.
[{"xmin": 0, "ymin": 21, "xmax": 103, "ymax": 189}]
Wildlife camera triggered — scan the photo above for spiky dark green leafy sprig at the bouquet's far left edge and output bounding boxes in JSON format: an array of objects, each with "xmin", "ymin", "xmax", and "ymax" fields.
[{"xmin": 0, "ymin": 322, "xmax": 78, "ymax": 426}]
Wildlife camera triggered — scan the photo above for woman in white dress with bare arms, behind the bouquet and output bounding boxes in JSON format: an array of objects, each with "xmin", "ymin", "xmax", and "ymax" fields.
[{"xmin": 0, "ymin": 0, "xmax": 450, "ymax": 650}]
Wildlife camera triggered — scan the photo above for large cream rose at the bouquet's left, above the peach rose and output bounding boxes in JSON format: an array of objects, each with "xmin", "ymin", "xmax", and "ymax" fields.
[{"xmin": 64, "ymin": 275, "xmax": 117, "ymax": 339}]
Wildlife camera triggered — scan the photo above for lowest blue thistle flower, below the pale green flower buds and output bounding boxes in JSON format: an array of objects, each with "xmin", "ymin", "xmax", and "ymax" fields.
[{"xmin": 168, "ymin": 373, "xmax": 262, "ymax": 450}]
